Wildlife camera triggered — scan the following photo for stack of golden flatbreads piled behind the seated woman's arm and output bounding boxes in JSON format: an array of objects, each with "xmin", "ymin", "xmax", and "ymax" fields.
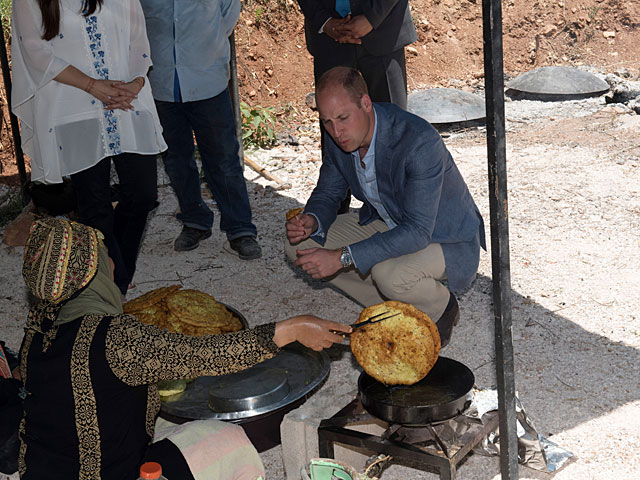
[{"xmin": 123, "ymin": 285, "xmax": 243, "ymax": 335}]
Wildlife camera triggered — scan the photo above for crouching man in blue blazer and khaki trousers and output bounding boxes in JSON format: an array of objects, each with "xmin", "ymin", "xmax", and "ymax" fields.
[{"xmin": 285, "ymin": 67, "xmax": 486, "ymax": 346}]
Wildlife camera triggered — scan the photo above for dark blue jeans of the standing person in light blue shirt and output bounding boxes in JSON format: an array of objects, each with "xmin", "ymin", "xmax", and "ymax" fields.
[{"xmin": 156, "ymin": 89, "xmax": 257, "ymax": 240}]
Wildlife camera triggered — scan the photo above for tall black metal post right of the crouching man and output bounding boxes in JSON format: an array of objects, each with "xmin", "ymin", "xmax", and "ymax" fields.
[{"xmin": 482, "ymin": 0, "xmax": 518, "ymax": 480}]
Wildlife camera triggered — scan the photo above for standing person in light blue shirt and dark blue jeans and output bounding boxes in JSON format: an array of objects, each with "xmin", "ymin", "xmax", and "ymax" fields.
[{"xmin": 141, "ymin": 0, "xmax": 262, "ymax": 260}]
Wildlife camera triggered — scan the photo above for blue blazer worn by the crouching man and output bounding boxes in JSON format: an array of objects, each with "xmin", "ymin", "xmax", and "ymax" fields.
[{"xmin": 305, "ymin": 103, "xmax": 486, "ymax": 291}]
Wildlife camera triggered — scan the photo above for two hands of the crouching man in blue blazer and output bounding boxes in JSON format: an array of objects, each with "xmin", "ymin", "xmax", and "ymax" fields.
[{"xmin": 286, "ymin": 213, "xmax": 342, "ymax": 278}]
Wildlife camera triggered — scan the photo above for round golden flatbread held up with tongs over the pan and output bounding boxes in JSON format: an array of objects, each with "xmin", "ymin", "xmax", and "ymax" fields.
[{"xmin": 351, "ymin": 300, "xmax": 440, "ymax": 385}]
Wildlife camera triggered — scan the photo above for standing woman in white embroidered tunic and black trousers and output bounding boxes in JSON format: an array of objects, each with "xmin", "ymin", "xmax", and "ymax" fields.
[{"xmin": 11, "ymin": 0, "xmax": 167, "ymax": 295}]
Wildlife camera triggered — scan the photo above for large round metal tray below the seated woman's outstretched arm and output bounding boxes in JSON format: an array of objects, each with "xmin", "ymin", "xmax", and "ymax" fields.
[{"xmin": 161, "ymin": 342, "xmax": 330, "ymax": 420}]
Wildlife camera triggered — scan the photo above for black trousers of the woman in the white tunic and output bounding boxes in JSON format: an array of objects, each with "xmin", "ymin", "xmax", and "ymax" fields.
[{"xmin": 71, "ymin": 153, "xmax": 158, "ymax": 294}]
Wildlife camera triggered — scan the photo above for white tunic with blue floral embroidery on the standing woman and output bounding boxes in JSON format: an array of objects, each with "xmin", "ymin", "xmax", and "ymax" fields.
[{"xmin": 11, "ymin": 0, "xmax": 167, "ymax": 183}]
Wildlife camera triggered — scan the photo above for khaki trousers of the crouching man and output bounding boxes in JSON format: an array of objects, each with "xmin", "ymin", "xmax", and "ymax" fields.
[{"xmin": 285, "ymin": 213, "xmax": 449, "ymax": 322}]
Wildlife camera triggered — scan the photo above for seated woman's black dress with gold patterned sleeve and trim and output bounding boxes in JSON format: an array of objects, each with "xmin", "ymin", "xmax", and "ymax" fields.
[{"xmin": 20, "ymin": 315, "xmax": 278, "ymax": 480}]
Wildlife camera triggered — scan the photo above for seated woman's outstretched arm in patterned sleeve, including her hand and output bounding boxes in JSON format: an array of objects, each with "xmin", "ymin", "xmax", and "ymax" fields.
[{"xmin": 106, "ymin": 315, "xmax": 351, "ymax": 385}]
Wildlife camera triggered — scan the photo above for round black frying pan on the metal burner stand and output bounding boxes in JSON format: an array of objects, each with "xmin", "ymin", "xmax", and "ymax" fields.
[{"xmin": 358, "ymin": 357, "xmax": 475, "ymax": 425}]
